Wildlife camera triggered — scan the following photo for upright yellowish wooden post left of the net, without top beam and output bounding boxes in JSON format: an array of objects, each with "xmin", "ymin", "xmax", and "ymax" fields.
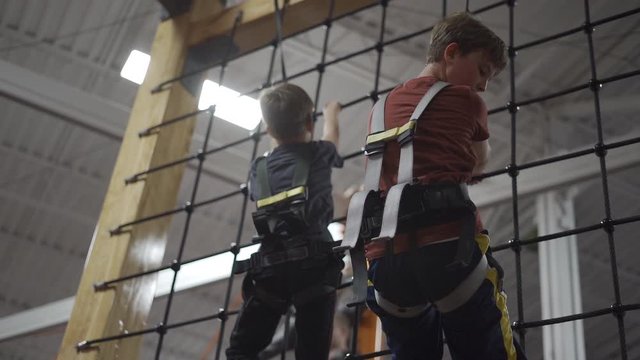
[{"xmin": 58, "ymin": 14, "xmax": 204, "ymax": 360}]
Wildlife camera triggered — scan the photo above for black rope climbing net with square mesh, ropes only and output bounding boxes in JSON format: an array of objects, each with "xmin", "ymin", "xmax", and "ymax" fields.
[{"xmin": 77, "ymin": 0, "xmax": 640, "ymax": 359}]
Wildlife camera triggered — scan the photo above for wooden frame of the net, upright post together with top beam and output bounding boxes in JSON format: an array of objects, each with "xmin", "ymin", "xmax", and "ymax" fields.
[{"xmin": 57, "ymin": 0, "xmax": 377, "ymax": 360}]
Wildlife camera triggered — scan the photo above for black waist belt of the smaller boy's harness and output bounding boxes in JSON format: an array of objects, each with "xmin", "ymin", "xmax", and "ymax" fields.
[{"xmin": 233, "ymin": 241, "xmax": 339, "ymax": 274}]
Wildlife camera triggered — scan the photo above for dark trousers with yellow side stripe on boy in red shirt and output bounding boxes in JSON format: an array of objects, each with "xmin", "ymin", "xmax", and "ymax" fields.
[{"xmin": 367, "ymin": 238, "xmax": 525, "ymax": 360}]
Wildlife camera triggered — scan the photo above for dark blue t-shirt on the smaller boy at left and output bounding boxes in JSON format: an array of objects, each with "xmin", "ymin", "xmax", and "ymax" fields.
[{"xmin": 249, "ymin": 141, "xmax": 343, "ymax": 239}]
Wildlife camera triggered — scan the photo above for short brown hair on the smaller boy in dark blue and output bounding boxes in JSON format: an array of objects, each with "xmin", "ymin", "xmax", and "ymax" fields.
[{"xmin": 260, "ymin": 84, "xmax": 313, "ymax": 140}]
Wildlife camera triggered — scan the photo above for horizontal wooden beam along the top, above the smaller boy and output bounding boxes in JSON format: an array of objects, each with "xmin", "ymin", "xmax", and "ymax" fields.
[{"xmin": 189, "ymin": 0, "xmax": 379, "ymax": 53}]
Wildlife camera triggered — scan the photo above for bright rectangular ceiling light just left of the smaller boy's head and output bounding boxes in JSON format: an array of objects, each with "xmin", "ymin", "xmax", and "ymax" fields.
[{"xmin": 198, "ymin": 80, "xmax": 262, "ymax": 130}]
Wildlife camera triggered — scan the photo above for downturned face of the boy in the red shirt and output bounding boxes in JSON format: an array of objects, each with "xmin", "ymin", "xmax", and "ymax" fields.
[{"xmin": 445, "ymin": 48, "xmax": 495, "ymax": 92}]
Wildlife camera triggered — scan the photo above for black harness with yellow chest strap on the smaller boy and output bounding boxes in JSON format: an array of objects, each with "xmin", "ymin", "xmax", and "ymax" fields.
[{"xmin": 234, "ymin": 146, "xmax": 336, "ymax": 274}]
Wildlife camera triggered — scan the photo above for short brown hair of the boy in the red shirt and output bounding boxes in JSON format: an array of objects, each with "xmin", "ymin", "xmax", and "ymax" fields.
[{"xmin": 427, "ymin": 12, "xmax": 507, "ymax": 72}]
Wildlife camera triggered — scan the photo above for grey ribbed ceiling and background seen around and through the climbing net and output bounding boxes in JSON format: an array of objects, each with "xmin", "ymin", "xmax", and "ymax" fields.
[{"xmin": 0, "ymin": 0, "xmax": 640, "ymax": 360}]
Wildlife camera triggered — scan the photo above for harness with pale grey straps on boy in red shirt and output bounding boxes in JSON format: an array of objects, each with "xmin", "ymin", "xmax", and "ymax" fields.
[{"xmin": 334, "ymin": 82, "xmax": 486, "ymax": 316}]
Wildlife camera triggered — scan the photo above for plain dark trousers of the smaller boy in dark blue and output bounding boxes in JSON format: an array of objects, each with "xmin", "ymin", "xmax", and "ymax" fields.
[{"xmin": 226, "ymin": 256, "xmax": 344, "ymax": 360}]
